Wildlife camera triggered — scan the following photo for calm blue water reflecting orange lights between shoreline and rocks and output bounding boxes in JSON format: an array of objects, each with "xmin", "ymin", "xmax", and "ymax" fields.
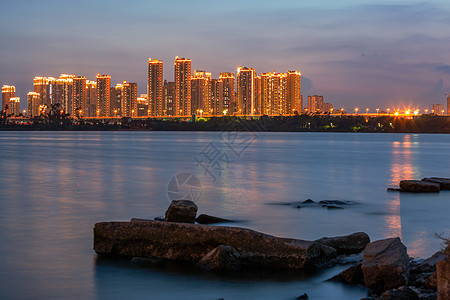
[{"xmin": 0, "ymin": 132, "xmax": 450, "ymax": 299}]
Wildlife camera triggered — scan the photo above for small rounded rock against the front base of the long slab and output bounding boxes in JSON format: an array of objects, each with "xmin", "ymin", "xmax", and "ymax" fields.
[{"xmin": 198, "ymin": 245, "xmax": 241, "ymax": 271}]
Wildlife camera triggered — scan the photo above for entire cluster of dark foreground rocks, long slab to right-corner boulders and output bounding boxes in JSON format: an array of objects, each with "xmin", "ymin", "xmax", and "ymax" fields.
[{"xmin": 94, "ymin": 200, "xmax": 450, "ymax": 300}]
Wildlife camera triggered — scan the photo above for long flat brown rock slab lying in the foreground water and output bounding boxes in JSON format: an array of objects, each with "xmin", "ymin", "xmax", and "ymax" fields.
[{"xmin": 94, "ymin": 221, "xmax": 336, "ymax": 269}]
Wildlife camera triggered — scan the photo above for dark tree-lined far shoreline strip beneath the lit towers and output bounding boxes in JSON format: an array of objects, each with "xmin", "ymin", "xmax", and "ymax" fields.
[{"xmin": 0, "ymin": 115, "xmax": 450, "ymax": 134}]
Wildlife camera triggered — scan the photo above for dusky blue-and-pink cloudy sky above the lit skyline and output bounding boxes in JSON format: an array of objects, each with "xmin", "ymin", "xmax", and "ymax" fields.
[{"xmin": 0, "ymin": 0, "xmax": 450, "ymax": 110}]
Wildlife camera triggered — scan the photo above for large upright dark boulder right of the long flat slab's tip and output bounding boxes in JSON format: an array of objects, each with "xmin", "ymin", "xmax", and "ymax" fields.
[{"xmin": 361, "ymin": 238, "xmax": 409, "ymax": 294}]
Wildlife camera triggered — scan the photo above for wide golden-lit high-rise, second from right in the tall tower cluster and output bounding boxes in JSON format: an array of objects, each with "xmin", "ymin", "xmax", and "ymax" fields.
[{"xmin": 261, "ymin": 72, "xmax": 287, "ymax": 115}]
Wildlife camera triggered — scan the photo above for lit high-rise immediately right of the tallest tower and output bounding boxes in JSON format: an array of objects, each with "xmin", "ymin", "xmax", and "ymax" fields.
[{"xmin": 191, "ymin": 70, "xmax": 212, "ymax": 114}]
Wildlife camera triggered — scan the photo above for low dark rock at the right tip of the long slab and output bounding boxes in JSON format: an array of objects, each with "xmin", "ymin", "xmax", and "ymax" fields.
[{"xmin": 316, "ymin": 232, "xmax": 370, "ymax": 255}]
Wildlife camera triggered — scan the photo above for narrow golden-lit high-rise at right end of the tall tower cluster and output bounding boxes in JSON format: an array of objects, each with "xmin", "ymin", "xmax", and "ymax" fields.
[{"xmin": 285, "ymin": 71, "xmax": 303, "ymax": 114}]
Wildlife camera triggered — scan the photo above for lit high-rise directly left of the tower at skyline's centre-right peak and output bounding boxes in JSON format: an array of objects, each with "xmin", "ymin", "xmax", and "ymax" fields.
[{"xmin": 215, "ymin": 73, "xmax": 236, "ymax": 115}]
